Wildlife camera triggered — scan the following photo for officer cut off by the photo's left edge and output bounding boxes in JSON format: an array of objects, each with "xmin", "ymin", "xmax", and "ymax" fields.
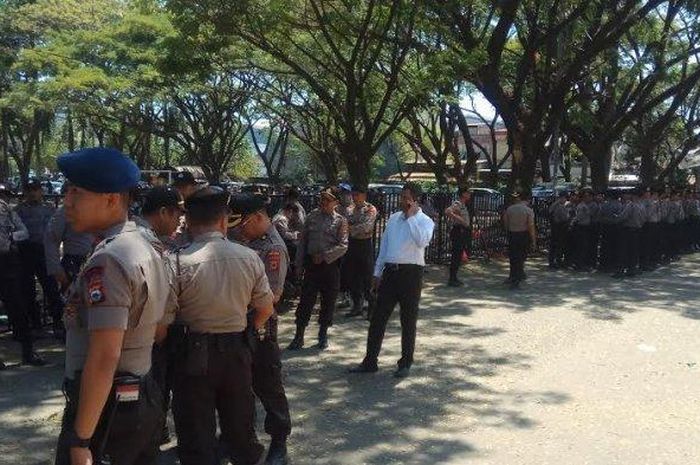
[{"xmin": 0, "ymin": 184, "xmax": 44, "ymax": 369}]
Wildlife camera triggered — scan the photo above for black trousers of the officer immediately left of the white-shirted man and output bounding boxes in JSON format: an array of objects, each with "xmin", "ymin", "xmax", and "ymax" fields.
[{"xmin": 343, "ymin": 238, "xmax": 374, "ymax": 311}]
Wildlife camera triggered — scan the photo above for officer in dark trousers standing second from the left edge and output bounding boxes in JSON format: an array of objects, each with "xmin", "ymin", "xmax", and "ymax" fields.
[{"xmin": 15, "ymin": 179, "xmax": 63, "ymax": 337}]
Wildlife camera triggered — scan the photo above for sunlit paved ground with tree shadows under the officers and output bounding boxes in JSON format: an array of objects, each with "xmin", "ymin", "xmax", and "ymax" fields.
[{"xmin": 0, "ymin": 256, "xmax": 700, "ymax": 465}]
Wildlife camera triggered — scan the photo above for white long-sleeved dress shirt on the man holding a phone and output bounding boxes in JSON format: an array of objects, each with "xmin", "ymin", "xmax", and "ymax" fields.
[{"xmin": 374, "ymin": 210, "xmax": 435, "ymax": 277}]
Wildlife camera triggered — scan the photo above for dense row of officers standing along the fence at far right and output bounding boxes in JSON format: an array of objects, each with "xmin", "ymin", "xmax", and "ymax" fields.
[{"xmin": 549, "ymin": 188, "xmax": 700, "ymax": 277}]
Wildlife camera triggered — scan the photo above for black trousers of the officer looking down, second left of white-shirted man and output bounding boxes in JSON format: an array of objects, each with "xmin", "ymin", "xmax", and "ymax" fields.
[{"xmin": 296, "ymin": 257, "xmax": 340, "ymax": 328}]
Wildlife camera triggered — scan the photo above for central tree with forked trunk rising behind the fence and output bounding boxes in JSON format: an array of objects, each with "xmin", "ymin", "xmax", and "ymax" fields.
[{"xmin": 169, "ymin": 0, "xmax": 432, "ymax": 184}]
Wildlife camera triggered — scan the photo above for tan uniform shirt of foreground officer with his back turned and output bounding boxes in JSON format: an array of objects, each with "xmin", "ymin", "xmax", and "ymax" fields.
[{"xmin": 176, "ymin": 232, "xmax": 274, "ymax": 334}]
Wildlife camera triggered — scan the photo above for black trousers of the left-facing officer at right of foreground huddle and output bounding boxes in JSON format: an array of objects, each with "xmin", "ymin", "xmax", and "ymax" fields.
[{"xmin": 253, "ymin": 316, "xmax": 292, "ymax": 440}]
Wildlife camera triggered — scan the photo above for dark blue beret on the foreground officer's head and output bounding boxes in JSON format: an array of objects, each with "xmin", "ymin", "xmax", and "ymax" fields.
[{"xmin": 56, "ymin": 147, "xmax": 141, "ymax": 194}]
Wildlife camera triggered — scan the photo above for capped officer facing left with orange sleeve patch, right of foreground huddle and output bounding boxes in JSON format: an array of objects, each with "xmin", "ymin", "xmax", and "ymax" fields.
[{"xmin": 230, "ymin": 194, "xmax": 292, "ymax": 465}]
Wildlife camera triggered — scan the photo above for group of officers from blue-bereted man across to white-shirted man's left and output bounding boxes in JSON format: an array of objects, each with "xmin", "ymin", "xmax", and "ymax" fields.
[{"xmin": 17, "ymin": 148, "xmax": 377, "ymax": 465}]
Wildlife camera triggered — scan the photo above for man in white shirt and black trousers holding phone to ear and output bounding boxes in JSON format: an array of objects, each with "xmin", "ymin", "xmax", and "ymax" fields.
[{"xmin": 349, "ymin": 183, "xmax": 435, "ymax": 378}]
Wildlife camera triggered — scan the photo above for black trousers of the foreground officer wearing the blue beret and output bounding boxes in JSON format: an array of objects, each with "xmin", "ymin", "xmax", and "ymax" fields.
[{"xmin": 55, "ymin": 375, "xmax": 163, "ymax": 465}]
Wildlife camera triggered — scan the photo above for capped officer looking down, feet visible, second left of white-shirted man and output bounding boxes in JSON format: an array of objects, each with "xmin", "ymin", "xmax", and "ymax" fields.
[{"xmin": 288, "ymin": 187, "xmax": 348, "ymax": 350}]
